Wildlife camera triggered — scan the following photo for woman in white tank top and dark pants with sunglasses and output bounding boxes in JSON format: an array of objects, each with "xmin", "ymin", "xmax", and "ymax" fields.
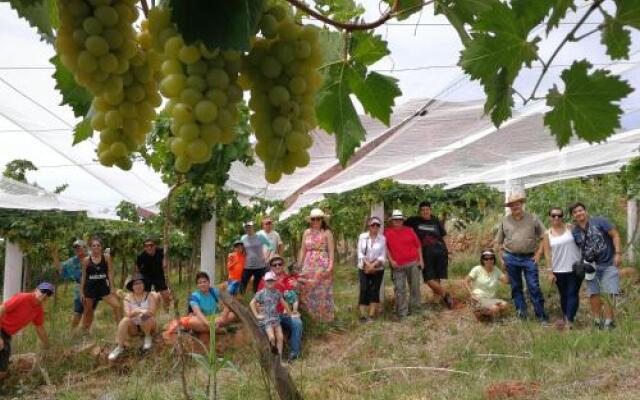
[{"xmin": 542, "ymin": 207, "xmax": 582, "ymax": 329}]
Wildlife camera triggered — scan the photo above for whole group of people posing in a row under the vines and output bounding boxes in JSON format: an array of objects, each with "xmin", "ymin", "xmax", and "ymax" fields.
[{"xmin": 0, "ymin": 194, "xmax": 622, "ymax": 378}]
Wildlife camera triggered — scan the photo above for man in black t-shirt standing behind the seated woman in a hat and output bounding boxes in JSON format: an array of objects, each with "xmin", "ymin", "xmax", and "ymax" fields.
[{"xmin": 136, "ymin": 238, "xmax": 171, "ymax": 310}]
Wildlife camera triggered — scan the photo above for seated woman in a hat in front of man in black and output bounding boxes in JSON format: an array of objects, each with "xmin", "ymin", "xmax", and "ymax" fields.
[{"xmin": 109, "ymin": 273, "xmax": 158, "ymax": 361}]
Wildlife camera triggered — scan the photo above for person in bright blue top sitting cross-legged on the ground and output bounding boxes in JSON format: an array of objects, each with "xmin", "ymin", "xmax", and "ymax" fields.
[{"xmin": 164, "ymin": 271, "xmax": 235, "ymax": 346}]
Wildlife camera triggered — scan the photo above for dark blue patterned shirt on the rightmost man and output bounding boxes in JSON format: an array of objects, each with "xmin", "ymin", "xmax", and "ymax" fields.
[{"xmin": 571, "ymin": 217, "xmax": 616, "ymax": 265}]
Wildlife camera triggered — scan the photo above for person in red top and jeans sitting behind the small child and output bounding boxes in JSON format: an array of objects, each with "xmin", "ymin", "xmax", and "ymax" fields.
[{"xmin": 258, "ymin": 254, "xmax": 302, "ymax": 362}]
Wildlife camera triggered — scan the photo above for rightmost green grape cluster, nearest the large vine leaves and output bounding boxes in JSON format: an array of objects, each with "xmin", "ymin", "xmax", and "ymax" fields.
[{"xmin": 240, "ymin": 4, "xmax": 322, "ymax": 183}]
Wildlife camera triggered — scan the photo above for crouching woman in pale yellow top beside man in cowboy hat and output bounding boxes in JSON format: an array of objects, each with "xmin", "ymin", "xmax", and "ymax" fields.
[{"xmin": 464, "ymin": 249, "xmax": 509, "ymax": 320}]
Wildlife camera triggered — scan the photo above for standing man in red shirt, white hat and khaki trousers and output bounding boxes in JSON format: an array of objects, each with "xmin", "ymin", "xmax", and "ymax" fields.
[{"xmin": 384, "ymin": 210, "xmax": 424, "ymax": 320}]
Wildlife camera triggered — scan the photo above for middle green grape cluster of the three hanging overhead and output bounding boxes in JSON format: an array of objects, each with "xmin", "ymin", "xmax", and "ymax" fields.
[{"xmin": 149, "ymin": 7, "xmax": 243, "ymax": 173}]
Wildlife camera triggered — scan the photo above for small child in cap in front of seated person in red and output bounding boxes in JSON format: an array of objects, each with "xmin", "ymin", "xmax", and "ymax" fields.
[{"xmin": 249, "ymin": 271, "xmax": 291, "ymax": 361}]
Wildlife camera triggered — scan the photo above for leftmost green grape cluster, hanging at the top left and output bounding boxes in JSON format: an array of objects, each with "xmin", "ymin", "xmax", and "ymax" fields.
[{"xmin": 56, "ymin": 0, "xmax": 162, "ymax": 170}]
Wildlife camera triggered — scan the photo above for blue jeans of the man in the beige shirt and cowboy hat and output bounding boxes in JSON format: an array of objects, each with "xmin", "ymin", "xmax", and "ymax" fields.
[{"xmin": 504, "ymin": 255, "xmax": 547, "ymax": 320}]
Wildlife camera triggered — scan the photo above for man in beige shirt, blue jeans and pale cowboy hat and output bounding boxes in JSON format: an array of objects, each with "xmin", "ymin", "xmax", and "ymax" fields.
[{"xmin": 495, "ymin": 192, "xmax": 549, "ymax": 325}]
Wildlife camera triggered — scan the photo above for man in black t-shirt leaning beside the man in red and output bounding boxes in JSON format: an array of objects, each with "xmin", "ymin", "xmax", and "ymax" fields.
[{"xmin": 404, "ymin": 201, "xmax": 453, "ymax": 308}]
